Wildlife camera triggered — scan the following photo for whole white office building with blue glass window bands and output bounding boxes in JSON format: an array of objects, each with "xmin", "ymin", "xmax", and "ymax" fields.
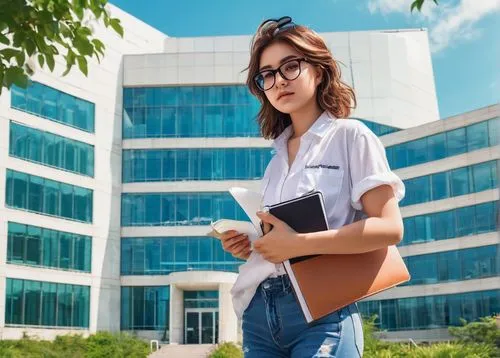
[{"xmin": 0, "ymin": 2, "xmax": 500, "ymax": 344}]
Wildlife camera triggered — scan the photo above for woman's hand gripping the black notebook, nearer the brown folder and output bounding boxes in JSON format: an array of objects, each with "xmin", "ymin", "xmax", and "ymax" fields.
[{"xmin": 253, "ymin": 211, "xmax": 300, "ymax": 264}]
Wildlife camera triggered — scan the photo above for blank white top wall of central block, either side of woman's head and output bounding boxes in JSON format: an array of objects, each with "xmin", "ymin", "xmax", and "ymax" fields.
[{"xmin": 123, "ymin": 30, "xmax": 439, "ymax": 129}]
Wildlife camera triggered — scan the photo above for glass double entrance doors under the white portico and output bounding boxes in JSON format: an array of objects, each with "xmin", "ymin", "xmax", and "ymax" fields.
[{"xmin": 184, "ymin": 308, "xmax": 219, "ymax": 344}]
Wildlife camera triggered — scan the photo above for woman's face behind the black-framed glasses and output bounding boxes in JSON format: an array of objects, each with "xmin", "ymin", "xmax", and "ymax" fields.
[{"xmin": 259, "ymin": 42, "xmax": 321, "ymax": 114}]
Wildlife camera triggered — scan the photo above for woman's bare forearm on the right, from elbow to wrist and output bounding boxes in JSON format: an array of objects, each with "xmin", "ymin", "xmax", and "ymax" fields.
[{"xmin": 296, "ymin": 217, "xmax": 403, "ymax": 256}]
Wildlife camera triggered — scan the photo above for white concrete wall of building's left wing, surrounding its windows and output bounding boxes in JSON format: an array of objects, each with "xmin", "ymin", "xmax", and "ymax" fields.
[{"xmin": 0, "ymin": 6, "xmax": 167, "ymax": 339}]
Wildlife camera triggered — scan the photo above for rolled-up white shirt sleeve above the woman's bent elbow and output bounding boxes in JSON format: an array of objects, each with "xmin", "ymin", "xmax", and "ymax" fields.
[{"xmin": 349, "ymin": 125, "xmax": 405, "ymax": 210}]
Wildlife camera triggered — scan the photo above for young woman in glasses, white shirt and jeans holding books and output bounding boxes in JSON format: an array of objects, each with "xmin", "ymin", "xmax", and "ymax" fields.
[{"xmin": 222, "ymin": 17, "xmax": 404, "ymax": 358}]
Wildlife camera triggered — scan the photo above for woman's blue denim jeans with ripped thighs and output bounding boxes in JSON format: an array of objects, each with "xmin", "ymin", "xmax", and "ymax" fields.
[{"xmin": 243, "ymin": 275, "xmax": 363, "ymax": 358}]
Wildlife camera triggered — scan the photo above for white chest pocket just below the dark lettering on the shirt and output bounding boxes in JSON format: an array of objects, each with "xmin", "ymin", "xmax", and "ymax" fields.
[{"xmin": 297, "ymin": 168, "xmax": 344, "ymax": 210}]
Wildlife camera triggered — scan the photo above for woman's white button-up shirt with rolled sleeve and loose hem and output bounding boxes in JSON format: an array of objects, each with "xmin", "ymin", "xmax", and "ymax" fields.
[{"xmin": 229, "ymin": 112, "xmax": 405, "ymax": 316}]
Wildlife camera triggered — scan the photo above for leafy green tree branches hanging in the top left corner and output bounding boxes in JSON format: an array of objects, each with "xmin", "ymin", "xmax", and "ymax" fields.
[{"xmin": 0, "ymin": 0, "xmax": 123, "ymax": 94}]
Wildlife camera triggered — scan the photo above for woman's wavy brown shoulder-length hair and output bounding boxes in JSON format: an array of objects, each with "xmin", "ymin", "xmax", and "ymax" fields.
[{"xmin": 246, "ymin": 24, "xmax": 356, "ymax": 139}]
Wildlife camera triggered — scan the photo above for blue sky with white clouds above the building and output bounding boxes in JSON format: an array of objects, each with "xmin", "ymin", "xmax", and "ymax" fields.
[{"xmin": 110, "ymin": 0, "xmax": 500, "ymax": 118}]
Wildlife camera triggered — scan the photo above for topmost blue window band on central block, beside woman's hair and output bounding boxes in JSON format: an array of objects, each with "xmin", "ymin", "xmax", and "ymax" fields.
[{"xmin": 123, "ymin": 86, "xmax": 260, "ymax": 138}]
